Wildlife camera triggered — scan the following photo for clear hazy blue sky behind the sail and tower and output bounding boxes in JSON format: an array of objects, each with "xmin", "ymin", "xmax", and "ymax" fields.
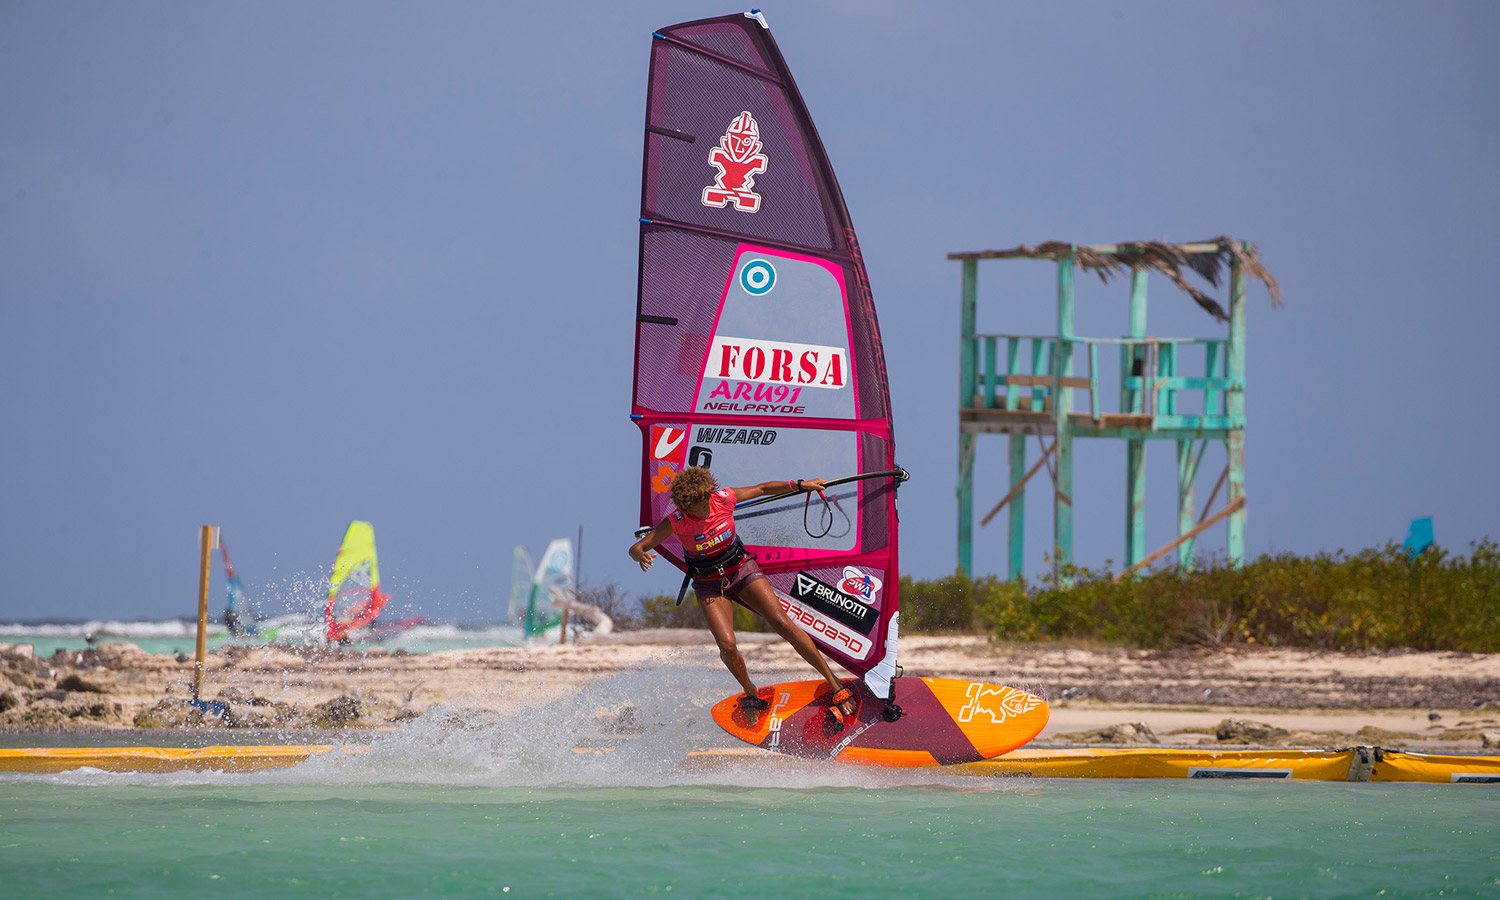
[{"xmin": 0, "ymin": 2, "xmax": 1500, "ymax": 621}]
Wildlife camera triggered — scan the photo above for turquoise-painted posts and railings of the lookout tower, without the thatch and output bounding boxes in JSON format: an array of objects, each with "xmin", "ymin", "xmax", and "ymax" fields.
[{"xmin": 950, "ymin": 235, "xmax": 1245, "ymax": 578}]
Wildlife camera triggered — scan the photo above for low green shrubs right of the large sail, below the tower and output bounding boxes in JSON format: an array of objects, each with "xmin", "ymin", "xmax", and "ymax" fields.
[{"xmin": 902, "ymin": 539, "xmax": 1500, "ymax": 653}]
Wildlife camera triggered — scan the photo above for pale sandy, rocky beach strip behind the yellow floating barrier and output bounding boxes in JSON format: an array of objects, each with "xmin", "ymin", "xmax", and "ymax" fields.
[{"xmin": 0, "ymin": 630, "xmax": 1500, "ymax": 753}]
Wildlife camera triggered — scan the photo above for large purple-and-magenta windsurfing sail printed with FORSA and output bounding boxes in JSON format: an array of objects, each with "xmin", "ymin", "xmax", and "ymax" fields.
[{"xmin": 630, "ymin": 11, "xmax": 905, "ymax": 701}]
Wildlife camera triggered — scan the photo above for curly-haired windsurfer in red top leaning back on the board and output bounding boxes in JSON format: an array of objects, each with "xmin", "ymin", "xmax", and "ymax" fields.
[{"xmin": 630, "ymin": 467, "xmax": 857, "ymax": 723}]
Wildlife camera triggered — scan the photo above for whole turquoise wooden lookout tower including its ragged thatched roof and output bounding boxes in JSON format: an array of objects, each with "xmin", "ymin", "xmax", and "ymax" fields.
[{"xmin": 948, "ymin": 237, "xmax": 1281, "ymax": 579}]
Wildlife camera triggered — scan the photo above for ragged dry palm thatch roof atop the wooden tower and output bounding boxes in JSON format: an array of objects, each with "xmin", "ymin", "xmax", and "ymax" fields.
[{"xmin": 948, "ymin": 236, "xmax": 1281, "ymax": 321}]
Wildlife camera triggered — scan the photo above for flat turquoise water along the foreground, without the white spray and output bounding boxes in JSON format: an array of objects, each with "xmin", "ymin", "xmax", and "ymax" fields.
[{"xmin": 0, "ymin": 779, "xmax": 1500, "ymax": 899}]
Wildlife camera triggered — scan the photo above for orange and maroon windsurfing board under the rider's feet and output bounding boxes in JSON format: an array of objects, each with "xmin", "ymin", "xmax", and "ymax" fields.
[{"xmin": 713, "ymin": 677, "xmax": 1049, "ymax": 767}]
